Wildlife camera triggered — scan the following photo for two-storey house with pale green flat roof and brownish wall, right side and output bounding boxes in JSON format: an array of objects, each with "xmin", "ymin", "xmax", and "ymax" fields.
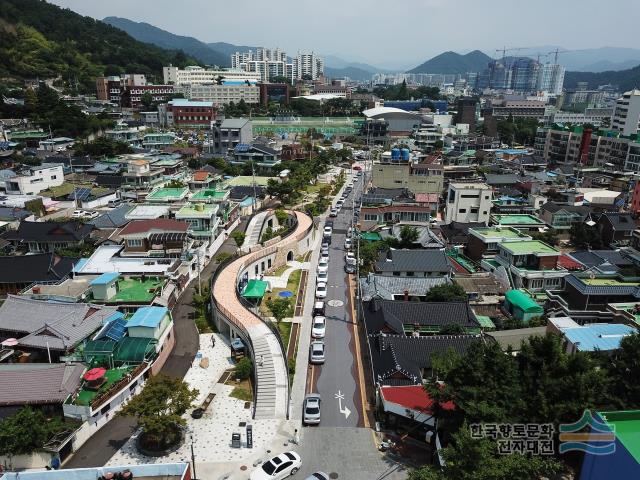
[{"xmin": 482, "ymin": 240, "xmax": 569, "ymax": 292}]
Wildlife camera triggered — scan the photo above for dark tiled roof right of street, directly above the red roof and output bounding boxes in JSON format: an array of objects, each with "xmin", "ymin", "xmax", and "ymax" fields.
[{"xmin": 369, "ymin": 334, "xmax": 481, "ymax": 385}]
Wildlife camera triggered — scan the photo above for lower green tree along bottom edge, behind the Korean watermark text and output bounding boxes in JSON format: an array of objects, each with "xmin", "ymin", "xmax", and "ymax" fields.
[{"xmin": 409, "ymin": 424, "xmax": 563, "ymax": 480}]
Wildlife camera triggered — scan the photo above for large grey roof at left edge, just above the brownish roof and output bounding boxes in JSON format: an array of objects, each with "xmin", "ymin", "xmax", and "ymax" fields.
[{"xmin": 0, "ymin": 295, "xmax": 117, "ymax": 351}]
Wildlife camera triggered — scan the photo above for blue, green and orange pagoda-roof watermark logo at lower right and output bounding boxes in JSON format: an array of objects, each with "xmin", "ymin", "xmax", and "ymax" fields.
[{"xmin": 559, "ymin": 410, "xmax": 616, "ymax": 455}]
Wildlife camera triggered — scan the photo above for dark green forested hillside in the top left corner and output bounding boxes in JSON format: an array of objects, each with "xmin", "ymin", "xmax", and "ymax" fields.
[{"xmin": 0, "ymin": 0, "xmax": 196, "ymax": 91}]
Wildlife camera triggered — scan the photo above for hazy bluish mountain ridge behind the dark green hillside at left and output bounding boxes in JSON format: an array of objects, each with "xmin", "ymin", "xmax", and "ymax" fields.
[{"xmin": 102, "ymin": 17, "xmax": 236, "ymax": 67}]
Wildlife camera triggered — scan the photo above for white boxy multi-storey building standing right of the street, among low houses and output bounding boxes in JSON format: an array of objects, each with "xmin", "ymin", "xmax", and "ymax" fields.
[{"xmin": 445, "ymin": 183, "xmax": 492, "ymax": 224}]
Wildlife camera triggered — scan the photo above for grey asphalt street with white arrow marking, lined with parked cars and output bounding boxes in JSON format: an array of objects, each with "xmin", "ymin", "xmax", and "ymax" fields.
[{"xmin": 312, "ymin": 172, "xmax": 364, "ymax": 427}]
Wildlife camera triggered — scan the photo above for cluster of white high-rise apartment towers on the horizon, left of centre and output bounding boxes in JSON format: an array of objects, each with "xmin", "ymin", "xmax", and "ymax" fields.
[{"xmin": 231, "ymin": 48, "xmax": 324, "ymax": 82}]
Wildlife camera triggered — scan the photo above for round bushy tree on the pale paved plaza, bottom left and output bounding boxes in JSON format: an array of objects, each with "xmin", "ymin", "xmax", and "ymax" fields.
[{"xmin": 118, "ymin": 374, "xmax": 198, "ymax": 450}]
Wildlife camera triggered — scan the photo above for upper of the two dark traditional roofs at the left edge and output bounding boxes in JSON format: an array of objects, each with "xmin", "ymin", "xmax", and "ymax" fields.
[{"xmin": 4, "ymin": 220, "xmax": 93, "ymax": 242}]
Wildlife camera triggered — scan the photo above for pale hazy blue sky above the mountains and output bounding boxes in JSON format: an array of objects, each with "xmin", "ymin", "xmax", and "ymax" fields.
[{"xmin": 50, "ymin": 0, "xmax": 640, "ymax": 68}]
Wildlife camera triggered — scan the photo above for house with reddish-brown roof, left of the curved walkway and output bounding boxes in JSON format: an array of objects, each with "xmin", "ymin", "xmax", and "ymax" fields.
[{"xmin": 120, "ymin": 218, "xmax": 192, "ymax": 258}]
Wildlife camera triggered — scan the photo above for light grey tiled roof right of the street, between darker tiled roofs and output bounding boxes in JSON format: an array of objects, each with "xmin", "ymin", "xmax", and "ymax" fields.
[{"xmin": 360, "ymin": 273, "xmax": 449, "ymax": 302}]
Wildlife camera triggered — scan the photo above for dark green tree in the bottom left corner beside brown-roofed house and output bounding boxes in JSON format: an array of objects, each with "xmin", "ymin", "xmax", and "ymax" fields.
[{"xmin": 0, "ymin": 407, "xmax": 49, "ymax": 457}]
